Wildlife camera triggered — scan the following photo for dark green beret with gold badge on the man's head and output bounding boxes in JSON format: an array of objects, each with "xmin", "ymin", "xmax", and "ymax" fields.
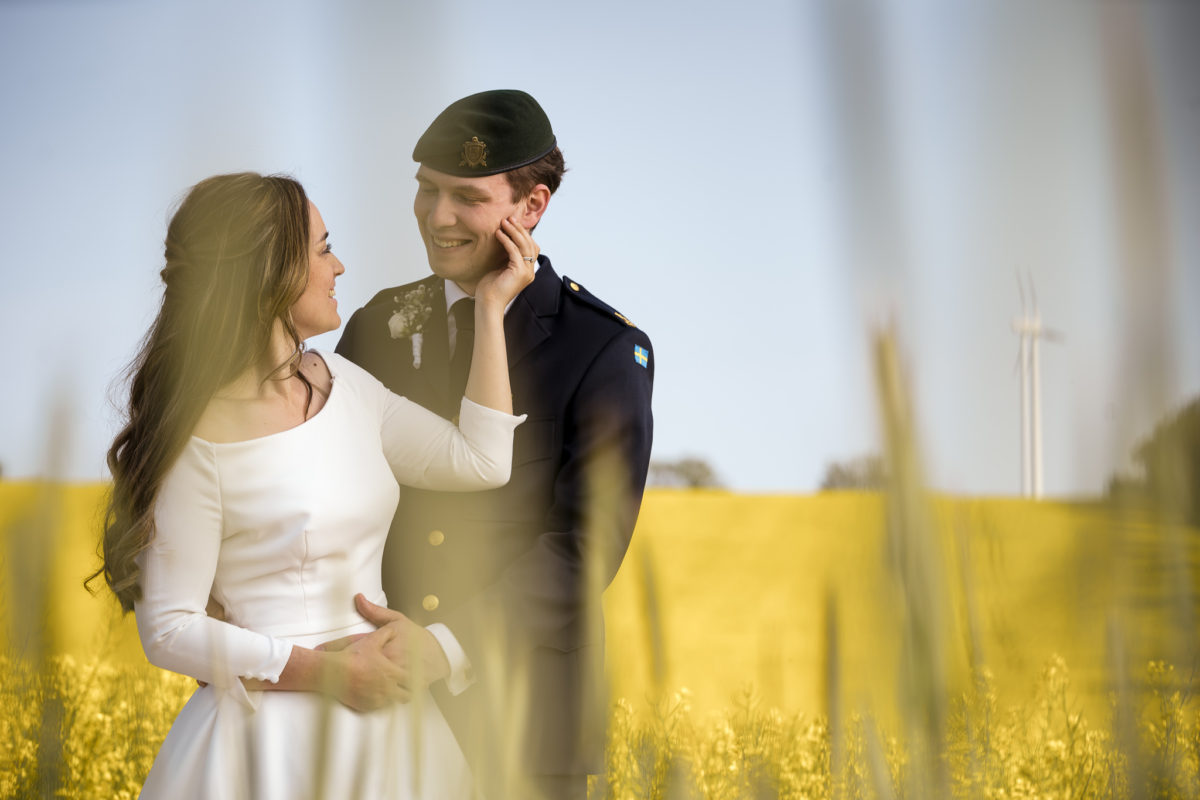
[{"xmin": 413, "ymin": 89, "xmax": 554, "ymax": 178}]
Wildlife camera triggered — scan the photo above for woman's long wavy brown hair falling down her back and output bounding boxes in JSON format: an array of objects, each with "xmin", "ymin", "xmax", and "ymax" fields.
[{"xmin": 86, "ymin": 173, "xmax": 312, "ymax": 612}]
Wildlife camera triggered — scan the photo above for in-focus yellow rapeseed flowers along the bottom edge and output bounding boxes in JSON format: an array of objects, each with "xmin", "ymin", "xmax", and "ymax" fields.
[{"xmin": 0, "ymin": 656, "xmax": 1200, "ymax": 800}]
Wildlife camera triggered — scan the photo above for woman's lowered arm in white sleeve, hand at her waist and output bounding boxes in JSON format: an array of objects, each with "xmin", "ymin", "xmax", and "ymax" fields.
[{"xmin": 134, "ymin": 441, "xmax": 404, "ymax": 709}]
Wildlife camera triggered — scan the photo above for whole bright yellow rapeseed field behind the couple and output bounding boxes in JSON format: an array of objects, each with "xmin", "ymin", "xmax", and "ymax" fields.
[{"xmin": 0, "ymin": 482, "xmax": 1200, "ymax": 798}]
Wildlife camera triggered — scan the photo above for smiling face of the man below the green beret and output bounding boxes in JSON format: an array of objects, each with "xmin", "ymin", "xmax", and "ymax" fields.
[{"xmin": 413, "ymin": 164, "xmax": 522, "ymax": 294}]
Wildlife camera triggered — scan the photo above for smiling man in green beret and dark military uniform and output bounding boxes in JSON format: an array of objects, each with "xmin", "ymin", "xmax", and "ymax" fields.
[{"xmin": 337, "ymin": 90, "xmax": 654, "ymax": 800}]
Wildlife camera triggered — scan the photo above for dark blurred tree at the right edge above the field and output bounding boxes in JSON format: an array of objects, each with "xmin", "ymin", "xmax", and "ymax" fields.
[{"xmin": 1108, "ymin": 397, "xmax": 1200, "ymax": 527}]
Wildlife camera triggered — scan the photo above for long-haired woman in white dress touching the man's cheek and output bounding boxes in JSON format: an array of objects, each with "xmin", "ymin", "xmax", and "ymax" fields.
[{"xmin": 92, "ymin": 173, "xmax": 536, "ymax": 799}]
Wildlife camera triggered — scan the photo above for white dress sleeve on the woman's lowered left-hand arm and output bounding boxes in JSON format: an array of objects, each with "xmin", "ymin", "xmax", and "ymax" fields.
[{"xmin": 134, "ymin": 439, "xmax": 292, "ymax": 705}]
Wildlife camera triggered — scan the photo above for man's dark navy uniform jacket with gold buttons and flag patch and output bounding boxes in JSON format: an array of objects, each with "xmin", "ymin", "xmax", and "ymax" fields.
[{"xmin": 337, "ymin": 255, "xmax": 654, "ymax": 792}]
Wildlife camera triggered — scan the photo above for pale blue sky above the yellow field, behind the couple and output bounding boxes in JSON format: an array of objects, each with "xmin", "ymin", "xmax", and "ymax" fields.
[{"xmin": 0, "ymin": 0, "xmax": 1200, "ymax": 495}]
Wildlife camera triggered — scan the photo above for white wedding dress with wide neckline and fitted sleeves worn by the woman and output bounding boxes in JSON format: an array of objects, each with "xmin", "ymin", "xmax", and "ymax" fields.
[{"xmin": 136, "ymin": 353, "xmax": 524, "ymax": 800}]
